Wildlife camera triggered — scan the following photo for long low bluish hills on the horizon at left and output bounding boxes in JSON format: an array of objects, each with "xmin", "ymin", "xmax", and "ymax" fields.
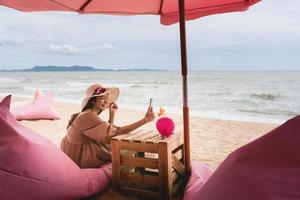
[{"xmin": 0, "ymin": 66, "xmax": 165, "ymax": 72}]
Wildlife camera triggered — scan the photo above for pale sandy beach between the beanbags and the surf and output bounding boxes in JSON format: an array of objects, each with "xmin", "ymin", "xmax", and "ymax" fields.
[{"xmin": 13, "ymin": 98, "xmax": 278, "ymax": 168}]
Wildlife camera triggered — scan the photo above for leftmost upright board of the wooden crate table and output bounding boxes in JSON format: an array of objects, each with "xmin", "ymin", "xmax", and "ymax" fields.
[{"xmin": 111, "ymin": 140, "xmax": 121, "ymax": 189}]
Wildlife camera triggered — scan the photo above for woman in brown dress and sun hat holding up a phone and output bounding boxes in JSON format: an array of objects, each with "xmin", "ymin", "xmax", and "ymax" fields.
[{"xmin": 61, "ymin": 84, "xmax": 154, "ymax": 168}]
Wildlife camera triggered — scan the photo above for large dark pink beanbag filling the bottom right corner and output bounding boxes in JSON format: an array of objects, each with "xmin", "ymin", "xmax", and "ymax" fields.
[{"xmin": 194, "ymin": 115, "xmax": 300, "ymax": 200}]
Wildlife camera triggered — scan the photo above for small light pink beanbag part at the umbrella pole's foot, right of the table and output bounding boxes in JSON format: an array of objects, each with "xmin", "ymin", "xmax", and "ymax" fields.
[{"xmin": 183, "ymin": 162, "xmax": 213, "ymax": 200}]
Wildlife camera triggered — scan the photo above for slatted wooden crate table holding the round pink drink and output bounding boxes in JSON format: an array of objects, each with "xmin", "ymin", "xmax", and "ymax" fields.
[{"xmin": 111, "ymin": 130, "xmax": 185, "ymax": 199}]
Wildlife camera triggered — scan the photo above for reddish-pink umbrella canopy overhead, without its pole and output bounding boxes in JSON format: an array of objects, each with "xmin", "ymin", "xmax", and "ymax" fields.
[{"xmin": 0, "ymin": 0, "xmax": 260, "ymax": 25}]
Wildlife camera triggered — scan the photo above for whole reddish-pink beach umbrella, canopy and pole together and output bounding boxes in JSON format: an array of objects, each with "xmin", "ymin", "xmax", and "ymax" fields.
[{"xmin": 0, "ymin": 0, "xmax": 260, "ymax": 172}]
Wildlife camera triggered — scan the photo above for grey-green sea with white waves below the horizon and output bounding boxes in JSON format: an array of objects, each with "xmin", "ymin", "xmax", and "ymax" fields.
[{"xmin": 0, "ymin": 71, "xmax": 300, "ymax": 123}]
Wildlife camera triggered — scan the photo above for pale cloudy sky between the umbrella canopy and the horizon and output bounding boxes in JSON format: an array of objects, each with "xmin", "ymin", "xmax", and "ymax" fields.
[{"xmin": 0, "ymin": 0, "xmax": 300, "ymax": 71}]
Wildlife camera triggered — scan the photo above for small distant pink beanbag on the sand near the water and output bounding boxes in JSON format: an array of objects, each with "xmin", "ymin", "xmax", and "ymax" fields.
[{"xmin": 11, "ymin": 93, "xmax": 60, "ymax": 120}]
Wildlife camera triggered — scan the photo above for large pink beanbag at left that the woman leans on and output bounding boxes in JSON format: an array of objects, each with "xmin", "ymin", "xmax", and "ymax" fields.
[{"xmin": 0, "ymin": 96, "xmax": 111, "ymax": 200}]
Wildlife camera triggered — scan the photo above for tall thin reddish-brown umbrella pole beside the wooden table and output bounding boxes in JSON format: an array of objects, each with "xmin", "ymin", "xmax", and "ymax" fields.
[{"xmin": 178, "ymin": 0, "xmax": 191, "ymax": 173}]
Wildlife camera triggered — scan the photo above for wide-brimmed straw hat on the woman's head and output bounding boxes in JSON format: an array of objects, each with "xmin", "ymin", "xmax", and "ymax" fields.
[{"xmin": 81, "ymin": 84, "xmax": 120, "ymax": 109}]
